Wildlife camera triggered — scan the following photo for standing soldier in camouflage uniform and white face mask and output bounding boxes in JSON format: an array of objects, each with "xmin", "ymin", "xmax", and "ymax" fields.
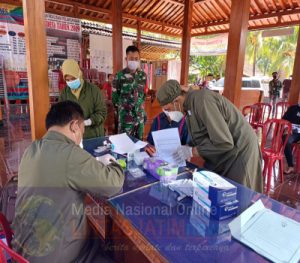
[{"xmin": 112, "ymin": 46, "xmax": 147, "ymax": 139}]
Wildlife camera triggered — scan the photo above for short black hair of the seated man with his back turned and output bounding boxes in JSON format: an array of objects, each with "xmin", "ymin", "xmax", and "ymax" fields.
[{"xmin": 46, "ymin": 100, "xmax": 84, "ymax": 130}]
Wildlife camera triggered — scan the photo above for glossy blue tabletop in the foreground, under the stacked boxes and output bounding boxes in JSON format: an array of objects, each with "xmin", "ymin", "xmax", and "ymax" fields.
[{"xmin": 109, "ymin": 174, "xmax": 300, "ymax": 263}]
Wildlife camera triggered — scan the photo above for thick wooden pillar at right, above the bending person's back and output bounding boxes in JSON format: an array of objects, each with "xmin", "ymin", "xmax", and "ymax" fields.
[{"xmin": 224, "ymin": 0, "xmax": 250, "ymax": 107}]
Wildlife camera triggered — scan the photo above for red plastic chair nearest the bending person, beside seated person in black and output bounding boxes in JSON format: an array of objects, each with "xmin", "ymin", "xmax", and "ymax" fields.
[{"xmin": 261, "ymin": 119, "xmax": 292, "ymax": 194}]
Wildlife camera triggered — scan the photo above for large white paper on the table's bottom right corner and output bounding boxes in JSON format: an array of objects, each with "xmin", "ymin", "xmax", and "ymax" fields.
[{"xmin": 229, "ymin": 200, "xmax": 300, "ymax": 263}]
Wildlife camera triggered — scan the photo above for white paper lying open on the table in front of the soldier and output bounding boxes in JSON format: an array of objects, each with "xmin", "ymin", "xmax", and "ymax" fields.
[{"xmin": 109, "ymin": 133, "xmax": 148, "ymax": 154}]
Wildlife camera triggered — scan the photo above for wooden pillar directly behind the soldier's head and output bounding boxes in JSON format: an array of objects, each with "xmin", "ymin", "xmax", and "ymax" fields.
[{"xmin": 112, "ymin": 0, "xmax": 124, "ymax": 74}]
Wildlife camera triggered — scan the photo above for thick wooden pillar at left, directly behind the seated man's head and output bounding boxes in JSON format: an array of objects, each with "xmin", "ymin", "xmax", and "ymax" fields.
[{"xmin": 23, "ymin": 0, "xmax": 49, "ymax": 140}]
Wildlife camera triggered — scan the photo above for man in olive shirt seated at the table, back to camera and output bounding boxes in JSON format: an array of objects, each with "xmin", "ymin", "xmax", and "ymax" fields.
[{"xmin": 13, "ymin": 101, "xmax": 124, "ymax": 263}]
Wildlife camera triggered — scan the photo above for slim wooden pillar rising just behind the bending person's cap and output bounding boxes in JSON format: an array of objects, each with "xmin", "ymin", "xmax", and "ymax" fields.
[{"xmin": 180, "ymin": 0, "xmax": 193, "ymax": 85}]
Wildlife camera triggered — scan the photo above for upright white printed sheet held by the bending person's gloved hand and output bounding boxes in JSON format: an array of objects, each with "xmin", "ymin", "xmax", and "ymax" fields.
[{"xmin": 152, "ymin": 128, "xmax": 186, "ymax": 167}]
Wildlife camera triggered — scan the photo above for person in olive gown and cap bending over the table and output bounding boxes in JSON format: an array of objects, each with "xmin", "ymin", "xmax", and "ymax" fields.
[{"xmin": 157, "ymin": 80, "xmax": 263, "ymax": 192}]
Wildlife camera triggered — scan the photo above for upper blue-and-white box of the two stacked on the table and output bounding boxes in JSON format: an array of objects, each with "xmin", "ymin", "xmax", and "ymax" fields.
[{"xmin": 193, "ymin": 171, "xmax": 237, "ymax": 205}]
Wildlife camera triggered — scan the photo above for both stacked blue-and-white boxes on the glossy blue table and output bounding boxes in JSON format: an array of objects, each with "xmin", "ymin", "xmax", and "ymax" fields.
[{"xmin": 193, "ymin": 171, "xmax": 239, "ymax": 220}]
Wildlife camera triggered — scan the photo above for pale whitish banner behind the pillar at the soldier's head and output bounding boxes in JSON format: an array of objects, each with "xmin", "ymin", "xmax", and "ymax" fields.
[{"xmin": 90, "ymin": 34, "xmax": 132, "ymax": 74}]
